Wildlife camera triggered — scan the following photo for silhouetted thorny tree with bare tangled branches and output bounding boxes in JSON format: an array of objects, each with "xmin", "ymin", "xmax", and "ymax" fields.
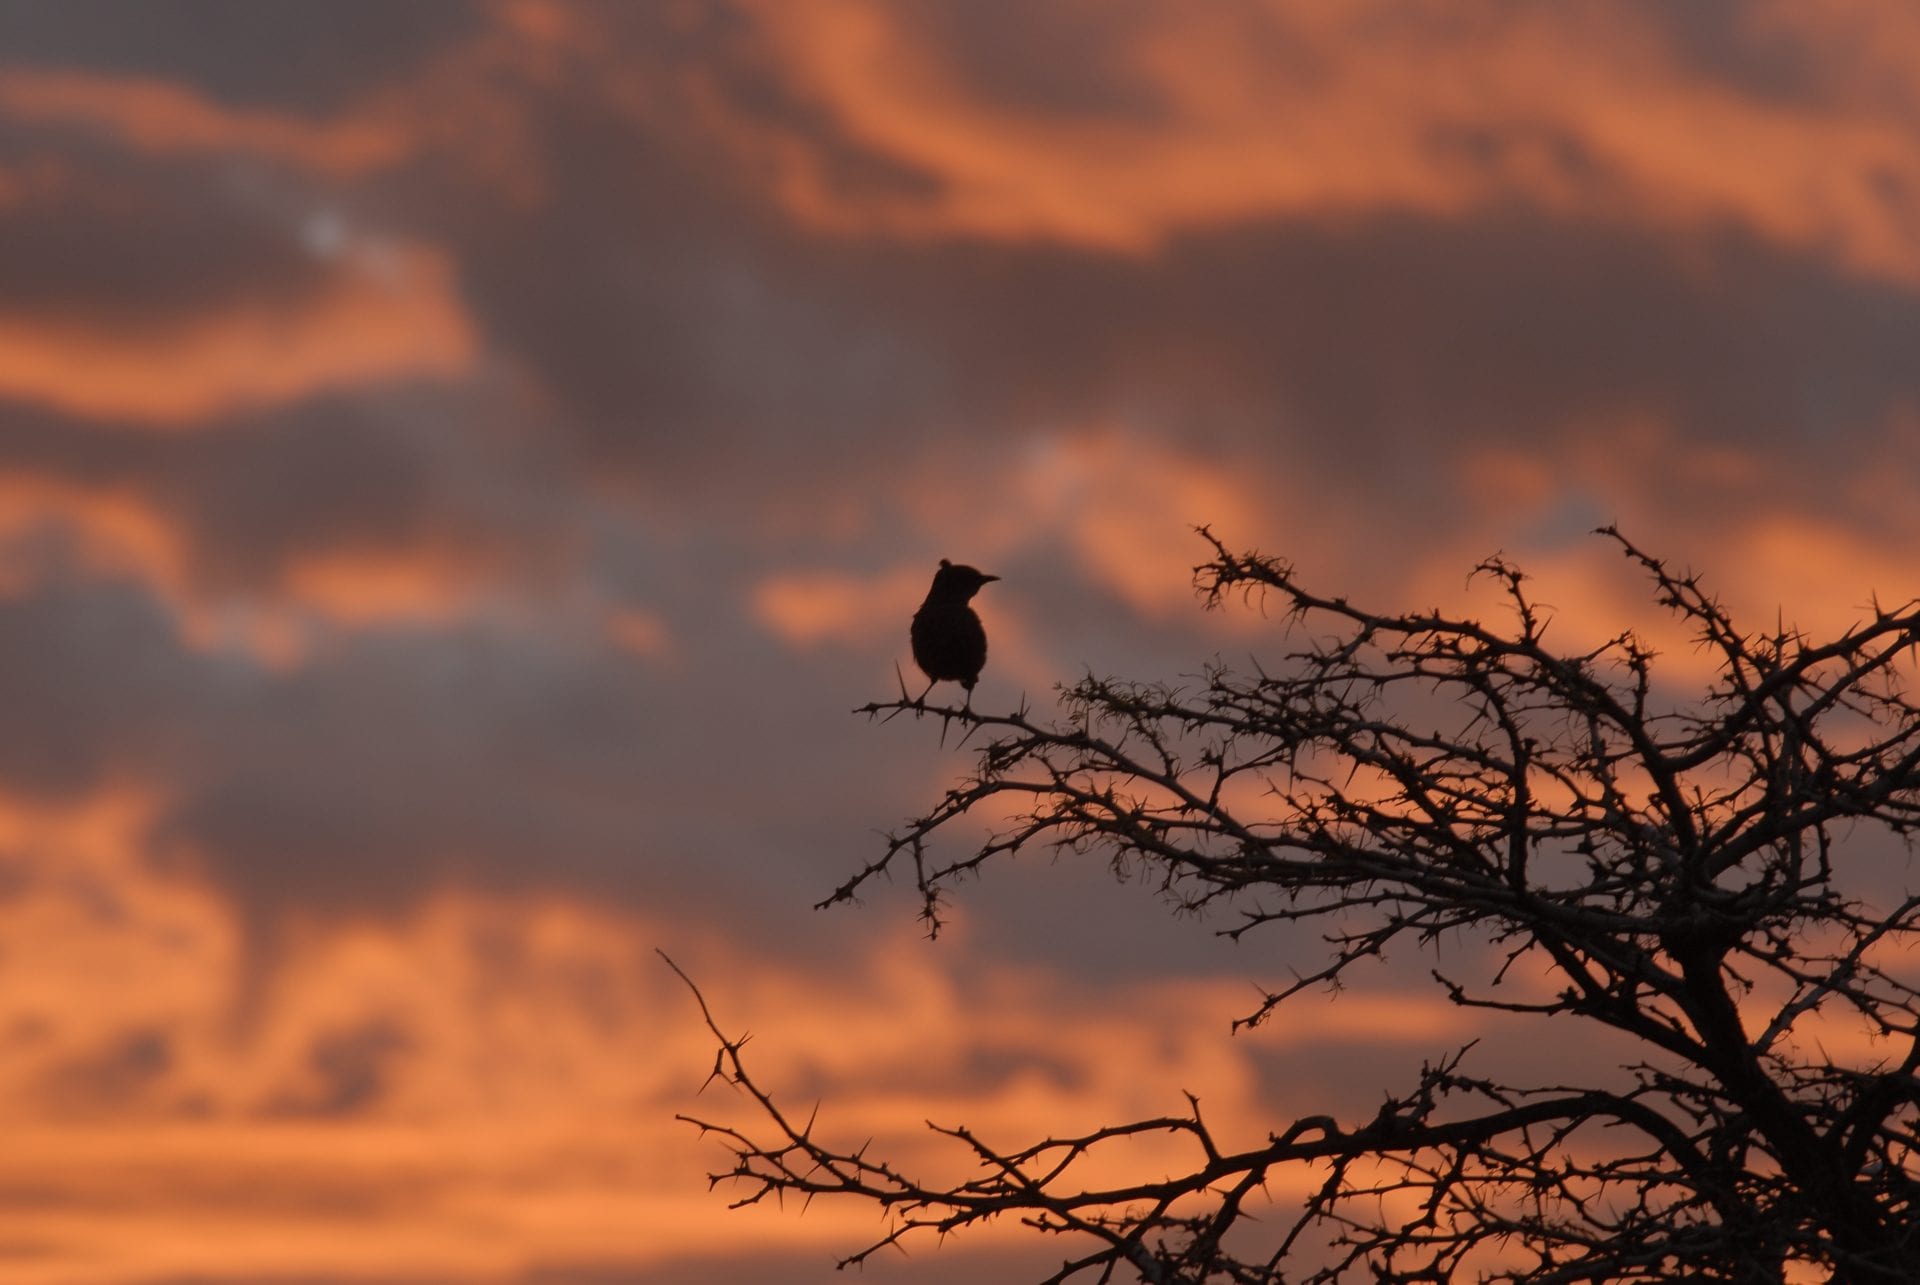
[{"xmin": 675, "ymin": 528, "xmax": 1920, "ymax": 1283}]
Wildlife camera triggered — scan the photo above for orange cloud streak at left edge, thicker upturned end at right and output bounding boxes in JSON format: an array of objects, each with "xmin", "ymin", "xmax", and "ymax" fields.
[{"xmin": 0, "ymin": 246, "xmax": 474, "ymax": 430}]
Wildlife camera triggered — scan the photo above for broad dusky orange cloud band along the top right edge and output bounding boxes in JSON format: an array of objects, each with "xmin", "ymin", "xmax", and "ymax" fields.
[{"xmin": 705, "ymin": 0, "xmax": 1920, "ymax": 282}]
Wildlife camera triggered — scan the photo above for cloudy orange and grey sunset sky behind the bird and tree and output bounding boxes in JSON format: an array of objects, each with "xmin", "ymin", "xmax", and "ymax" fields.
[{"xmin": 0, "ymin": 0, "xmax": 1920, "ymax": 1285}]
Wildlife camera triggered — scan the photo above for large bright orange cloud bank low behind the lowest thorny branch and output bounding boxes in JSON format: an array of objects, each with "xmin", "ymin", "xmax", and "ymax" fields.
[{"xmin": 0, "ymin": 775, "xmax": 1489, "ymax": 1285}]
